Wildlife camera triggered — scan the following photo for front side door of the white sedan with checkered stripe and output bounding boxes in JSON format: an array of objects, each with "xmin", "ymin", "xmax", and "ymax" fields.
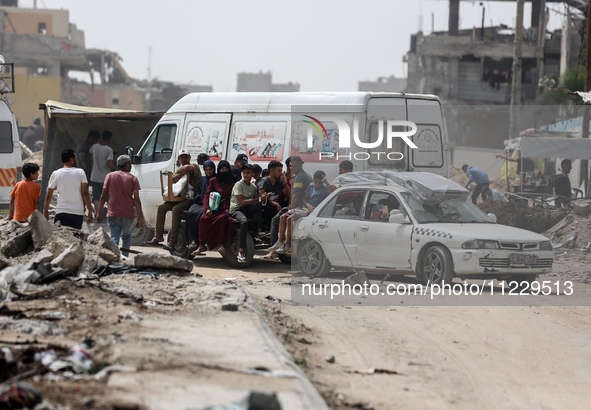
[{"xmin": 356, "ymin": 190, "xmax": 412, "ymax": 270}]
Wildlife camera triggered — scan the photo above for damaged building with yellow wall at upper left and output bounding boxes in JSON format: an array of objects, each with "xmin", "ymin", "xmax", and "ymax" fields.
[{"xmin": 0, "ymin": 0, "xmax": 213, "ymax": 130}]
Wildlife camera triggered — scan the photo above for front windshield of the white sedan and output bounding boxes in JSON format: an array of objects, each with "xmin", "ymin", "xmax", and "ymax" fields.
[{"xmin": 402, "ymin": 192, "xmax": 494, "ymax": 224}]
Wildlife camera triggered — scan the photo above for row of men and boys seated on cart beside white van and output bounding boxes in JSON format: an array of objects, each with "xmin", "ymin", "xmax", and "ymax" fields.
[{"xmin": 150, "ymin": 149, "xmax": 353, "ymax": 262}]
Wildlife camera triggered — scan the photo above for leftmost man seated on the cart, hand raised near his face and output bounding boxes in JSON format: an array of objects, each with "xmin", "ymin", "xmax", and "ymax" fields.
[{"xmin": 149, "ymin": 148, "xmax": 201, "ymax": 251}]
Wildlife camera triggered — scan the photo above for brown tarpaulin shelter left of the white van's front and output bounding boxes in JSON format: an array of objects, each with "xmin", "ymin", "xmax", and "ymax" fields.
[{"xmin": 39, "ymin": 100, "xmax": 164, "ymax": 200}]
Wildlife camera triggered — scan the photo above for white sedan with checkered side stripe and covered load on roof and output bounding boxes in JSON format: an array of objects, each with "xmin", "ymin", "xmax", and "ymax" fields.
[{"xmin": 292, "ymin": 172, "xmax": 554, "ymax": 283}]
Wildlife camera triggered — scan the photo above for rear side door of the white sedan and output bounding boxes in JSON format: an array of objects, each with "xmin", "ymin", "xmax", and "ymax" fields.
[{"xmin": 312, "ymin": 189, "xmax": 367, "ymax": 267}]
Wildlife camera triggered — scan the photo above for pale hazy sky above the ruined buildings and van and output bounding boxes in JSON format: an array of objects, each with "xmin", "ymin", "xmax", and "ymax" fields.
[{"xmin": 19, "ymin": 0, "xmax": 563, "ymax": 92}]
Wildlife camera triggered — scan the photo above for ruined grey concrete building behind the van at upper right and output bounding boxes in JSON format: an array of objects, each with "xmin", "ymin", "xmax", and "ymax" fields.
[{"xmin": 405, "ymin": 0, "xmax": 587, "ymax": 173}]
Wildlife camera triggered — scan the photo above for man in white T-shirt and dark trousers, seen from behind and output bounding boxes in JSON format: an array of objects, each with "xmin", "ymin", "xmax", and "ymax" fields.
[{"xmin": 43, "ymin": 148, "xmax": 92, "ymax": 229}]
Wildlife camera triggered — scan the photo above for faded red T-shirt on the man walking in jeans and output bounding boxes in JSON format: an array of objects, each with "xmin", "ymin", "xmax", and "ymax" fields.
[{"xmin": 103, "ymin": 171, "xmax": 141, "ymax": 218}]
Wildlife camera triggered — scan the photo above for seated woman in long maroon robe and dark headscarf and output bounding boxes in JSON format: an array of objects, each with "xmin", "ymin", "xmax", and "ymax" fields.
[{"xmin": 199, "ymin": 161, "xmax": 236, "ymax": 256}]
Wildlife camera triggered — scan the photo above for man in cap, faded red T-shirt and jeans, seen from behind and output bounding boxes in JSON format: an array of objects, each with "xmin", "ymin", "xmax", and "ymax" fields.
[{"xmin": 96, "ymin": 155, "xmax": 143, "ymax": 256}]
